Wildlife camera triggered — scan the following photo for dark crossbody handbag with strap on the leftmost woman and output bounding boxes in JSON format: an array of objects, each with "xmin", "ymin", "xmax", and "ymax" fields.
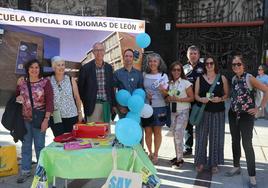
[{"xmin": 27, "ymin": 81, "xmax": 46, "ymax": 129}]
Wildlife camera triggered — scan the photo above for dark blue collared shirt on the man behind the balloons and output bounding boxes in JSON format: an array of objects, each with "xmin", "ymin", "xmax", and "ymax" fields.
[{"xmin": 114, "ymin": 67, "xmax": 143, "ymax": 93}]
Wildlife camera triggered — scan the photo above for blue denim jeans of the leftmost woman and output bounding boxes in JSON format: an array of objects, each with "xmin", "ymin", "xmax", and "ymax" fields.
[{"xmin": 21, "ymin": 121, "xmax": 46, "ymax": 172}]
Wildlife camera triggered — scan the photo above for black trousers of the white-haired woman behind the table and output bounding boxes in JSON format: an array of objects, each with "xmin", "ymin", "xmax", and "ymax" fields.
[{"xmin": 49, "ymin": 116, "xmax": 78, "ymax": 137}]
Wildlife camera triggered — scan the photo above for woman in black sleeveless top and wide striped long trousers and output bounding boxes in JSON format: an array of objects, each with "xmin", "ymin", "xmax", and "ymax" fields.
[{"xmin": 195, "ymin": 56, "xmax": 228, "ymax": 173}]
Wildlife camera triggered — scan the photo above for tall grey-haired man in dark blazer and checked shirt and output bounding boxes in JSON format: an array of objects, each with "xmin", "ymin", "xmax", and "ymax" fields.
[{"xmin": 78, "ymin": 42, "xmax": 116, "ymax": 123}]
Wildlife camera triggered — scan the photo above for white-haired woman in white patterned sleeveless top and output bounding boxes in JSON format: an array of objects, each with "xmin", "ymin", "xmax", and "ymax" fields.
[{"xmin": 49, "ymin": 56, "xmax": 82, "ymax": 137}]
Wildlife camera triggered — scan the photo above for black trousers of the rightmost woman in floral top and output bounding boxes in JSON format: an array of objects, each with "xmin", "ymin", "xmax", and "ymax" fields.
[{"xmin": 228, "ymin": 110, "xmax": 256, "ymax": 176}]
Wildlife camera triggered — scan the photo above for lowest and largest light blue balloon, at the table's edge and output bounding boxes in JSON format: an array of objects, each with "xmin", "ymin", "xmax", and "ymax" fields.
[{"xmin": 115, "ymin": 118, "xmax": 142, "ymax": 146}]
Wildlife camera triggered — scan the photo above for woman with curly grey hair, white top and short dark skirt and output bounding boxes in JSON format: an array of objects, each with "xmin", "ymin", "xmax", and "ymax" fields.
[{"xmin": 142, "ymin": 53, "xmax": 168, "ymax": 164}]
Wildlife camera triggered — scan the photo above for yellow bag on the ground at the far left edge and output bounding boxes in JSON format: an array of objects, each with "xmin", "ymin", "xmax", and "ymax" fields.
[{"xmin": 0, "ymin": 145, "xmax": 18, "ymax": 177}]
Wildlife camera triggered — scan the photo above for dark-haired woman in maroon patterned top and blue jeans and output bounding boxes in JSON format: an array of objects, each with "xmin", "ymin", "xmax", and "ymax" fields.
[{"xmin": 17, "ymin": 59, "xmax": 53, "ymax": 183}]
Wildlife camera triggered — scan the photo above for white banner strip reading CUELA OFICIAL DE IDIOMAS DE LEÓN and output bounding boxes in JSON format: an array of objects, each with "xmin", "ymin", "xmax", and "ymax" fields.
[{"xmin": 0, "ymin": 8, "xmax": 145, "ymax": 33}]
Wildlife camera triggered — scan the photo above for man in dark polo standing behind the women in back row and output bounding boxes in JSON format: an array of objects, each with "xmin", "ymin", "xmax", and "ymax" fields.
[{"xmin": 183, "ymin": 45, "xmax": 204, "ymax": 156}]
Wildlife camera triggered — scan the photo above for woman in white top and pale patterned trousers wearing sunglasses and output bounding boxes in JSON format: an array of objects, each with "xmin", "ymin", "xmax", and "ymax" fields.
[{"xmin": 166, "ymin": 61, "xmax": 194, "ymax": 168}]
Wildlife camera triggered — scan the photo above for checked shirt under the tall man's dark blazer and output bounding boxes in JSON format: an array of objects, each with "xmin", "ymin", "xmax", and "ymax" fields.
[{"xmin": 96, "ymin": 66, "xmax": 107, "ymax": 101}]
